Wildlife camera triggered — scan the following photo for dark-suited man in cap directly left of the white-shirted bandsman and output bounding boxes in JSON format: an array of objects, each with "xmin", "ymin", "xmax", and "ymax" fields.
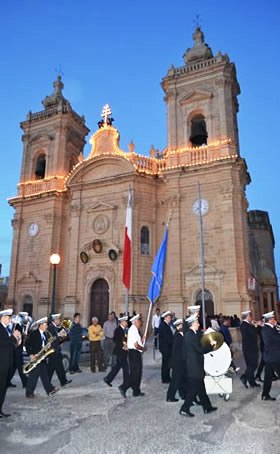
[{"xmin": 104, "ymin": 315, "xmax": 129, "ymax": 387}]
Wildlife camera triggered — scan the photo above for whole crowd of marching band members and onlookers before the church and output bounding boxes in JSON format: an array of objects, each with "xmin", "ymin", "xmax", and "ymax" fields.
[{"xmin": 0, "ymin": 306, "xmax": 280, "ymax": 419}]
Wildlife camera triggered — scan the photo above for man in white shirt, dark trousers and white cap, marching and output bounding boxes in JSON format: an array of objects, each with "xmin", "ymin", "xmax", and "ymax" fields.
[{"xmin": 119, "ymin": 314, "xmax": 145, "ymax": 397}]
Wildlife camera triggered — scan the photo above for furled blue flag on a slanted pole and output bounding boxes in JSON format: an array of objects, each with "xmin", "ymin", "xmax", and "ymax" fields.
[{"xmin": 147, "ymin": 225, "xmax": 168, "ymax": 304}]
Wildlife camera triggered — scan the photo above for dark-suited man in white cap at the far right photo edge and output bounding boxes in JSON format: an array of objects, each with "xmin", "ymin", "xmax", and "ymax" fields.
[{"xmin": 262, "ymin": 311, "xmax": 280, "ymax": 400}]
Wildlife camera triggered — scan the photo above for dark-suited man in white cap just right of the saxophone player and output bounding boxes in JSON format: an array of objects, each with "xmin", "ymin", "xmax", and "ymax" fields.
[{"xmin": 48, "ymin": 314, "xmax": 72, "ymax": 386}]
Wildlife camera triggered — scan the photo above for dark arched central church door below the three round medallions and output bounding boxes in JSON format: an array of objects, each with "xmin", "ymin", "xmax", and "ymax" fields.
[{"xmin": 89, "ymin": 279, "xmax": 109, "ymax": 324}]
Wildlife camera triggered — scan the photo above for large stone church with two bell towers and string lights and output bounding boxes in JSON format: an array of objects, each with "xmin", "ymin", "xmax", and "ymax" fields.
[{"xmin": 8, "ymin": 27, "xmax": 278, "ymax": 324}]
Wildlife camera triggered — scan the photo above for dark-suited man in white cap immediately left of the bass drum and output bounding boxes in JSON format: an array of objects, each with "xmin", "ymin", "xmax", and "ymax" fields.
[{"xmin": 179, "ymin": 314, "xmax": 217, "ymax": 417}]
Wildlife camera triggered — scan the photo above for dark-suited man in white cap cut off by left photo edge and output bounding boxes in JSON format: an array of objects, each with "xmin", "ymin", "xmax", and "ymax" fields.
[{"xmin": 0, "ymin": 309, "xmax": 21, "ymax": 419}]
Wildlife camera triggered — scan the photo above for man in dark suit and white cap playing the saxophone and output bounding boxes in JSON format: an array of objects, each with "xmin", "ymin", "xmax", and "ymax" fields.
[{"xmin": 25, "ymin": 317, "xmax": 58, "ymax": 399}]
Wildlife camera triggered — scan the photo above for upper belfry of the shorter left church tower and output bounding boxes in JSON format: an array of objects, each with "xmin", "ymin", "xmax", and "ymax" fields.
[{"xmin": 20, "ymin": 76, "xmax": 89, "ymax": 184}]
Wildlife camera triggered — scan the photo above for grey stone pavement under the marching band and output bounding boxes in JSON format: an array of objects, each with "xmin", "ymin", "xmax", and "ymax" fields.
[{"xmin": 0, "ymin": 348, "xmax": 280, "ymax": 454}]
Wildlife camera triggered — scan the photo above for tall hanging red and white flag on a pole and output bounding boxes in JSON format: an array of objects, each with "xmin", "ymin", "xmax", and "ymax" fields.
[{"xmin": 123, "ymin": 189, "xmax": 132, "ymax": 289}]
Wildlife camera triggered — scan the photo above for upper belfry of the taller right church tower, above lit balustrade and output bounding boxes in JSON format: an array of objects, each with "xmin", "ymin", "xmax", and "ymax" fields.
[{"xmin": 162, "ymin": 27, "xmax": 240, "ymax": 153}]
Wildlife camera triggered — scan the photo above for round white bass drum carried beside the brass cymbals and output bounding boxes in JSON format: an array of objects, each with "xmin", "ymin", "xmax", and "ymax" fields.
[{"xmin": 204, "ymin": 342, "xmax": 231, "ymax": 377}]
